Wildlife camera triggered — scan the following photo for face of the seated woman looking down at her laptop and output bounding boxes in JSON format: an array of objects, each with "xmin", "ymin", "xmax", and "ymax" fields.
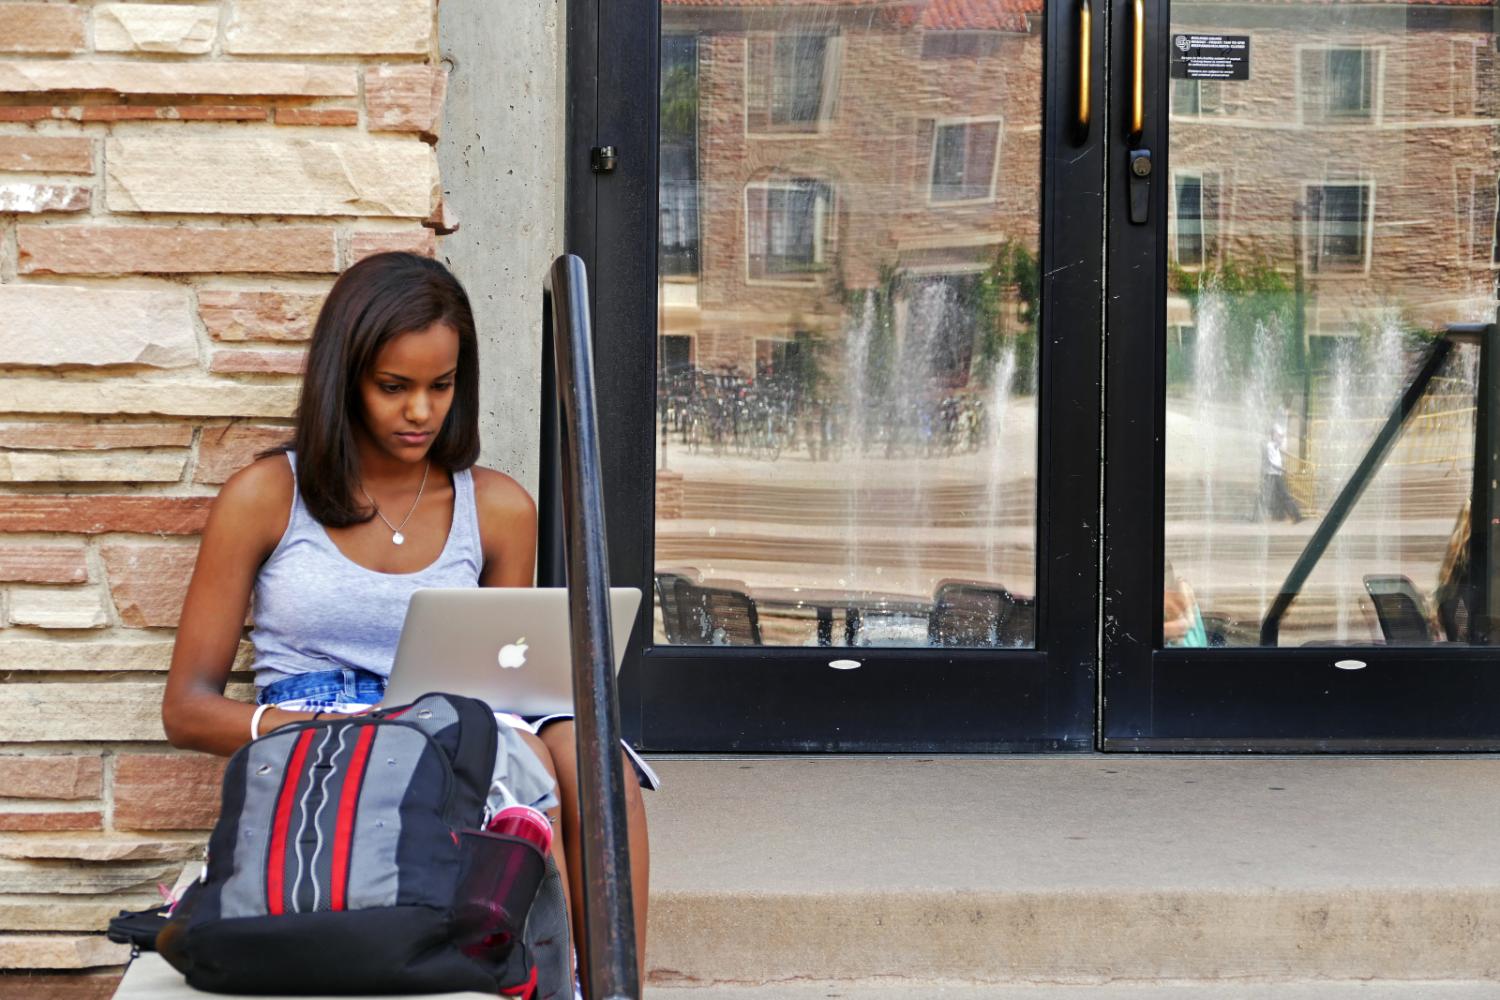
[{"xmin": 360, "ymin": 322, "xmax": 459, "ymax": 462}]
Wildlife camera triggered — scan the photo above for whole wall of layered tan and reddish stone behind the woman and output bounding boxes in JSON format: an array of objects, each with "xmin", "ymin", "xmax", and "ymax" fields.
[{"xmin": 0, "ymin": 0, "xmax": 444, "ymax": 1000}]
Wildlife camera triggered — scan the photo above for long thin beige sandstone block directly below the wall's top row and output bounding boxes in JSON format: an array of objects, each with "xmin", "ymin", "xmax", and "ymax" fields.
[{"xmin": 0, "ymin": 60, "xmax": 359, "ymax": 97}]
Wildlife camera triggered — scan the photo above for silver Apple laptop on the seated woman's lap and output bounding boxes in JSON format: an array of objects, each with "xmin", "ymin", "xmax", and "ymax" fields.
[{"xmin": 384, "ymin": 586, "xmax": 641, "ymax": 715}]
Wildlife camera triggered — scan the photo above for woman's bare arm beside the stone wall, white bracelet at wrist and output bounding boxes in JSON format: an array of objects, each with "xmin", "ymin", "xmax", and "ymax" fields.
[{"xmin": 162, "ymin": 456, "xmax": 312, "ymax": 756}]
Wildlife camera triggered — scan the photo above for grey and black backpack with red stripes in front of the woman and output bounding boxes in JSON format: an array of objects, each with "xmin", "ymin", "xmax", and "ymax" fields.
[{"xmin": 156, "ymin": 694, "xmax": 573, "ymax": 1000}]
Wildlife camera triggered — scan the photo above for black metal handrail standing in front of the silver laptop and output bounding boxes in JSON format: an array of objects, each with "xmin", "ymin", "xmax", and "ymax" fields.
[{"xmin": 540, "ymin": 253, "xmax": 641, "ymax": 1000}]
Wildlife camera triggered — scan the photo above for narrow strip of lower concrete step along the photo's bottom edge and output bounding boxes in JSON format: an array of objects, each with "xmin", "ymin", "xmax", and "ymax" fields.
[{"xmin": 645, "ymin": 981, "xmax": 1500, "ymax": 1000}]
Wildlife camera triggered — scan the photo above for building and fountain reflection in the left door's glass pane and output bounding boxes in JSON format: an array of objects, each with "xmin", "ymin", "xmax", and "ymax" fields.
[{"xmin": 656, "ymin": 0, "xmax": 1041, "ymax": 646}]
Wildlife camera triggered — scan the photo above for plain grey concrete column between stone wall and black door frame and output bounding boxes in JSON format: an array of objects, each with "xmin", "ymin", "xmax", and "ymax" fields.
[{"xmin": 438, "ymin": 0, "xmax": 566, "ymax": 496}]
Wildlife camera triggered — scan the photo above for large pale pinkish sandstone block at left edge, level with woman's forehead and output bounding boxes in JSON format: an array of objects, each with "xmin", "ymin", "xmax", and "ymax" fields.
[{"xmin": 0, "ymin": 285, "xmax": 198, "ymax": 367}]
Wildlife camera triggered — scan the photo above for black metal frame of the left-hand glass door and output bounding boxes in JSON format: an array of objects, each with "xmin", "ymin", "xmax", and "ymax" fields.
[{"xmin": 564, "ymin": 0, "xmax": 1104, "ymax": 753}]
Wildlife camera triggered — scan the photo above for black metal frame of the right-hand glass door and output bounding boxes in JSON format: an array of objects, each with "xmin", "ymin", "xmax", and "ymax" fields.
[{"xmin": 1101, "ymin": 0, "xmax": 1500, "ymax": 753}]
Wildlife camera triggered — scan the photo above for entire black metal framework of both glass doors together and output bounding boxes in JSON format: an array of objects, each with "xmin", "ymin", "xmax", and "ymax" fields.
[{"xmin": 555, "ymin": 0, "xmax": 1500, "ymax": 753}]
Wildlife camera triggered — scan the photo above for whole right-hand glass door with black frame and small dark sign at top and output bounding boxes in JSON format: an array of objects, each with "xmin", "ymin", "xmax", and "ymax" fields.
[{"xmin": 1104, "ymin": 0, "xmax": 1500, "ymax": 750}]
